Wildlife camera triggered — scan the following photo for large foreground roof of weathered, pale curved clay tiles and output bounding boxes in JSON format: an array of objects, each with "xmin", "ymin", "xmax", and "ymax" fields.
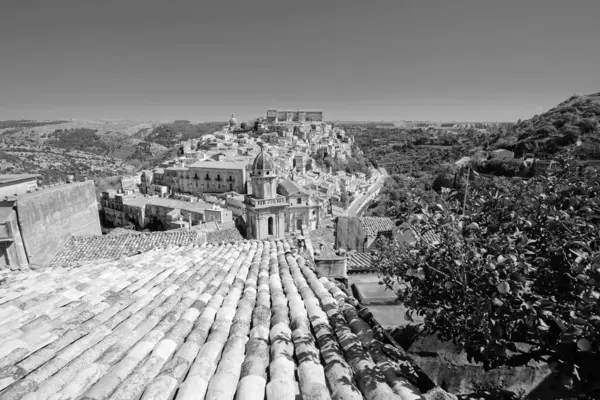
[{"xmin": 0, "ymin": 240, "xmax": 449, "ymax": 400}]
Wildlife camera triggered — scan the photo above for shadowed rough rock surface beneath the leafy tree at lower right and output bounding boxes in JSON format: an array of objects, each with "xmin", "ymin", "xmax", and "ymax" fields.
[{"xmin": 408, "ymin": 336, "xmax": 551, "ymax": 394}]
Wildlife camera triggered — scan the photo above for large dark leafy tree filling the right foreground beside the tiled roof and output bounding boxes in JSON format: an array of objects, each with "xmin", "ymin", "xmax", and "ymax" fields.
[{"xmin": 374, "ymin": 159, "xmax": 600, "ymax": 398}]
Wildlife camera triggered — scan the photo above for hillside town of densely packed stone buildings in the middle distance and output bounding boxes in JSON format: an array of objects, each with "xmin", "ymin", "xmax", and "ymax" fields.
[{"xmin": 100, "ymin": 111, "xmax": 381, "ymax": 239}]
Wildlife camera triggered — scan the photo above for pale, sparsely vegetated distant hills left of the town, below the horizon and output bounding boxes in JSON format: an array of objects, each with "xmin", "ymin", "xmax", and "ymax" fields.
[{"xmin": 0, "ymin": 120, "xmax": 225, "ymax": 182}]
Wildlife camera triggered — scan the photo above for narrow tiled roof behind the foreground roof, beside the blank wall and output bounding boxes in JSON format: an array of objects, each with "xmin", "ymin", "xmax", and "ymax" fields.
[{"xmin": 50, "ymin": 230, "xmax": 200, "ymax": 266}]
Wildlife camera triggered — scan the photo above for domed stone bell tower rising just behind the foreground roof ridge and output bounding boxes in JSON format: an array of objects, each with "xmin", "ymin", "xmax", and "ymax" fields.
[{"xmin": 245, "ymin": 147, "xmax": 288, "ymax": 240}]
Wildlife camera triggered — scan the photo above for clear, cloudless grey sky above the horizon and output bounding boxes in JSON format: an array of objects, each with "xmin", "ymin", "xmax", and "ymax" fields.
[{"xmin": 0, "ymin": 0, "xmax": 600, "ymax": 121}]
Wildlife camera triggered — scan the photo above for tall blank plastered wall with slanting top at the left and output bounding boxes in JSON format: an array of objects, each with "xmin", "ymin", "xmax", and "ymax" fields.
[{"xmin": 17, "ymin": 180, "xmax": 102, "ymax": 265}]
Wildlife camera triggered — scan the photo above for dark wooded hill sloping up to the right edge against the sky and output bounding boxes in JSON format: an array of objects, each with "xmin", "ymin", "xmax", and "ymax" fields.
[{"xmin": 492, "ymin": 93, "xmax": 600, "ymax": 159}]
